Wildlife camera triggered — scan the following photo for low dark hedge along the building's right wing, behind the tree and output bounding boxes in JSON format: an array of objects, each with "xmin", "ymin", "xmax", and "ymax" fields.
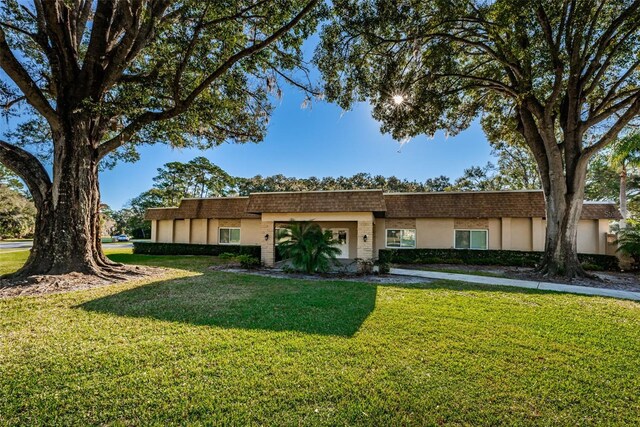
[{"xmin": 378, "ymin": 249, "xmax": 620, "ymax": 271}]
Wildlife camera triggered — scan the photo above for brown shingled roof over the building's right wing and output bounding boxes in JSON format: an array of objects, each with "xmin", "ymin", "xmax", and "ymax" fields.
[{"xmin": 384, "ymin": 191, "xmax": 620, "ymax": 219}]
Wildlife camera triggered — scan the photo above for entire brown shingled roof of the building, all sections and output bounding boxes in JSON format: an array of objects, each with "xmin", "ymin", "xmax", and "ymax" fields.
[{"xmin": 145, "ymin": 190, "xmax": 620, "ymax": 220}]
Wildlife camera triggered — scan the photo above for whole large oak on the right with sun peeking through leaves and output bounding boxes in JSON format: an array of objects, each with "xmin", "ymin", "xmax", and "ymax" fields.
[{"xmin": 316, "ymin": 0, "xmax": 640, "ymax": 277}]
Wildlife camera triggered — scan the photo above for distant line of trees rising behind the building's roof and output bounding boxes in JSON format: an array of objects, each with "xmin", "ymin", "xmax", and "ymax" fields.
[{"xmin": 102, "ymin": 144, "xmax": 640, "ymax": 238}]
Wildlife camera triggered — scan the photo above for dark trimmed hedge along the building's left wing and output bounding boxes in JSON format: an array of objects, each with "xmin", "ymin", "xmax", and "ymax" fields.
[{"xmin": 133, "ymin": 242, "xmax": 260, "ymax": 259}]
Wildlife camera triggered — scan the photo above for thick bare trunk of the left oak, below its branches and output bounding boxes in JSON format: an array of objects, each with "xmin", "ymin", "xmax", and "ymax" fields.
[{"xmin": 15, "ymin": 126, "xmax": 118, "ymax": 277}]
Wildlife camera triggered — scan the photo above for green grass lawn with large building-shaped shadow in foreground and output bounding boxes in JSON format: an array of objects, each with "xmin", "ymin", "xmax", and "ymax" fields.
[{"xmin": 0, "ymin": 254, "xmax": 640, "ymax": 426}]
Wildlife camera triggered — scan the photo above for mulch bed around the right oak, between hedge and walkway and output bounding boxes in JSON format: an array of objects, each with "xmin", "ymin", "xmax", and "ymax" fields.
[{"xmin": 398, "ymin": 264, "xmax": 640, "ymax": 292}]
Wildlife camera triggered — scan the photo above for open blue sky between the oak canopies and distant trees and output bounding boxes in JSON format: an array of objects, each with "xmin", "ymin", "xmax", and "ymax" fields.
[{"xmin": 100, "ymin": 93, "xmax": 492, "ymax": 208}]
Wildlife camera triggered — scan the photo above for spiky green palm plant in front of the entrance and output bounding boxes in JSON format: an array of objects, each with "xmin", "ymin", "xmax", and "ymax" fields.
[{"xmin": 278, "ymin": 221, "xmax": 340, "ymax": 274}]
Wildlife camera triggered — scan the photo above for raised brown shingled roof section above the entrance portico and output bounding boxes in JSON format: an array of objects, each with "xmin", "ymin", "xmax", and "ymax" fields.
[{"xmin": 247, "ymin": 190, "xmax": 386, "ymax": 213}]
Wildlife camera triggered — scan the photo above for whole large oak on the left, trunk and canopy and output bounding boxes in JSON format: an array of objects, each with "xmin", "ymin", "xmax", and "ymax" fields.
[{"xmin": 0, "ymin": 0, "xmax": 320, "ymax": 276}]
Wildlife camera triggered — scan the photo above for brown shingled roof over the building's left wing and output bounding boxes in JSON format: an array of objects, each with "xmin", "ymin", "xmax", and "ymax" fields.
[{"xmin": 145, "ymin": 197, "xmax": 260, "ymax": 219}]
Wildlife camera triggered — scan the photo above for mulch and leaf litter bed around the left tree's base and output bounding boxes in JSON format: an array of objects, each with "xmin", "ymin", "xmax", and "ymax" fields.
[{"xmin": 0, "ymin": 265, "xmax": 167, "ymax": 298}]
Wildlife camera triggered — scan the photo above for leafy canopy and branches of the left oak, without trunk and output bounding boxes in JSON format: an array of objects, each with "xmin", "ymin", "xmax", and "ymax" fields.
[{"xmin": 0, "ymin": 0, "xmax": 323, "ymax": 165}]
